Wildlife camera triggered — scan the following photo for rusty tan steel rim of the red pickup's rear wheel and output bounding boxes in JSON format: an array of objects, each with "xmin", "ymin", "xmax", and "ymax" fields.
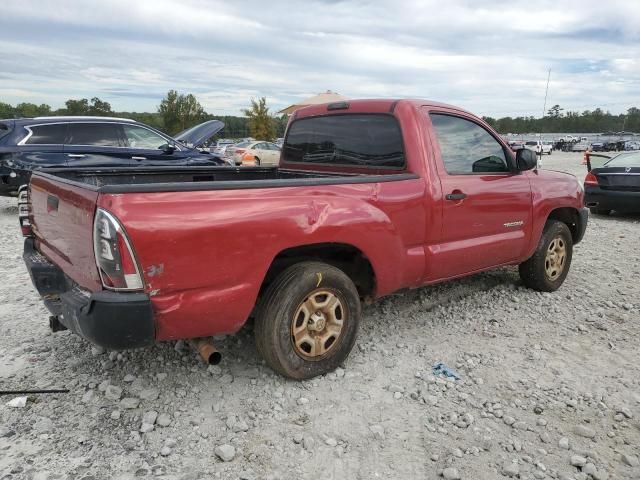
[{"xmin": 291, "ymin": 288, "xmax": 348, "ymax": 361}]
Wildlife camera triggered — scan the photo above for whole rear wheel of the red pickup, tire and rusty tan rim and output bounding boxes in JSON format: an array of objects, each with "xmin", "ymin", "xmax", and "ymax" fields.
[{"xmin": 255, "ymin": 262, "xmax": 360, "ymax": 380}]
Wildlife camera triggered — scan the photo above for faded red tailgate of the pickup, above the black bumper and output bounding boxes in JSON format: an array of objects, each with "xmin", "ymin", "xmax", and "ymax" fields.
[{"xmin": 29, "ymin": 173, "xmax": 102, "ymax": 292}]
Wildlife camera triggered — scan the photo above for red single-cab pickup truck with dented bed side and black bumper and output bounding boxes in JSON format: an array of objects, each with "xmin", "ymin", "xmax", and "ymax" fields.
[{"xmin": 20, "ymin": 100, "xmax": 587, "ymax": 379}]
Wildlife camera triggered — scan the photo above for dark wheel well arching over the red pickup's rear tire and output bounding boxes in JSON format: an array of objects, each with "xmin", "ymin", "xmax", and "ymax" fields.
[{"xmin": 260, "ymin": 243, "xmax": 375, "ymax": 298}]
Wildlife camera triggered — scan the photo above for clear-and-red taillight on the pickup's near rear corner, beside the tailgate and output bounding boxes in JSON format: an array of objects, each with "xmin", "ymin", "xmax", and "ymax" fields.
[{"xmin": 93, "ymin": 208, "xmax": 143, "ymax": 290}]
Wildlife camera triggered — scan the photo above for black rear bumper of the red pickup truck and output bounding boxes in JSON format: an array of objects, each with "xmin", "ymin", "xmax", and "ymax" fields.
[{"xmin": 23, "ymin": 238, "xmax": 156, "ymax": 350}]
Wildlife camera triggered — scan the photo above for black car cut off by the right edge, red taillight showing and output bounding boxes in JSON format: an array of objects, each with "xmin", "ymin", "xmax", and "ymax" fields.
[{"xmin": 584, "ymin": 152, "xmax": 640, "ymax": 215}]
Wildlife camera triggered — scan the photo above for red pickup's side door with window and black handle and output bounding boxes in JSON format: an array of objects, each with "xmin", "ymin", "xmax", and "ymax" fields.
[{"xmin": 427, "ymin": 112, "xmax": 532, "ymax": 280}]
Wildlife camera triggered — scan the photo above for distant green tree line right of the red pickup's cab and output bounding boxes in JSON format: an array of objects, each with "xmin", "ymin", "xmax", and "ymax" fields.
[{"xmin": 483, "ymin": 105, "xmax": 640, "ymax": 134}]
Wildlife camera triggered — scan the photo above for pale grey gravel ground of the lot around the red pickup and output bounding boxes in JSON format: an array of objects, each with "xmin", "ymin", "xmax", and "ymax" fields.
[{"xmin": 0, "ymin": 153, "xmax": 640, "ymax": 480}]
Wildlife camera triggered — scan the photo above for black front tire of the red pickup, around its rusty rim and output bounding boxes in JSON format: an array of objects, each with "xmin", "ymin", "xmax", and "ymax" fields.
[{"xmin": 519, "ymin": 220, "xmax": 573, "ymax": 292}]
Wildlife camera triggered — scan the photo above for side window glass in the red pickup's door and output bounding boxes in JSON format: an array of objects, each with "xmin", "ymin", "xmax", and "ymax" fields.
[{"xmin": 430, "ymin": 113, "xmax": 511, "ymax": 175}]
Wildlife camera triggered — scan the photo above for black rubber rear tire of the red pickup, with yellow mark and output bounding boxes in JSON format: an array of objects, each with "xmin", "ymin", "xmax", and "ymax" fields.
[{"xmin": 255, "ymin": 262, "xmax": 361, "ymax": 380}]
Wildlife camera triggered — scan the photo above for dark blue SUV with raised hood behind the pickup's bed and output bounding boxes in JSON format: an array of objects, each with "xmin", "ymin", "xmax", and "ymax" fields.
[{"xmin": 0, "ymin": 117, "xmax": 227, "ymax": 196}]
